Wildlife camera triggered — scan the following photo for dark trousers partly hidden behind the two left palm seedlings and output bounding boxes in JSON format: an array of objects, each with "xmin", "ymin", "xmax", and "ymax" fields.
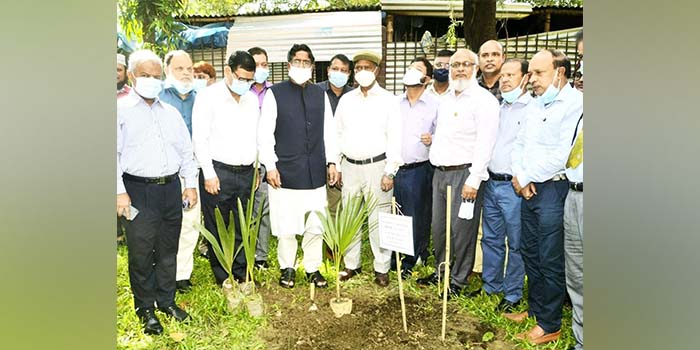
[{"xmin": 199, "ymin": 163, "xmax": 254, "ymax": 284}]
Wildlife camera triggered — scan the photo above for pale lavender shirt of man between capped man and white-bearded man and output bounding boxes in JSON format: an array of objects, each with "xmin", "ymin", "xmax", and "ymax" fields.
[{"xmin": 399, "ymin": 91, "xmax": 438, "ymax": 164}]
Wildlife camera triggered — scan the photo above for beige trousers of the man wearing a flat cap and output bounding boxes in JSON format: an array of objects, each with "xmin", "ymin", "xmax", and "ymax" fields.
[{"xmin": 341, "ymin": 159, "xmax": 394, "ymax": 273}]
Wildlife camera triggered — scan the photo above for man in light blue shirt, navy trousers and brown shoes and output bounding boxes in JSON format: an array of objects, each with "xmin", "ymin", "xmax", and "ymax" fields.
[{"xmin": 505, "ymin": 49, "xmax": 583, "ymax": 344}]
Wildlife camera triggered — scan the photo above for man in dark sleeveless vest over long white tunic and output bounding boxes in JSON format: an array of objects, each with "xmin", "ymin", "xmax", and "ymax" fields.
[{"xmin": 258, "ymin": 44, "xmax": 339, "ymax": 288}]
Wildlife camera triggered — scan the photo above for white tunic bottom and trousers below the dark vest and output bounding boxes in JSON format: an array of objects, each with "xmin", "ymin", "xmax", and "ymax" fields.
[{"xmin": 268, "ymin": 186, "xmax": 328, "ymax": 273}]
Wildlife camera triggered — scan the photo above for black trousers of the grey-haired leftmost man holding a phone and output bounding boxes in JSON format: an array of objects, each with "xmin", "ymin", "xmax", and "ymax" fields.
[{"xmin": 124, "ymin": 178, "xmax": 182, "ymax": 309}]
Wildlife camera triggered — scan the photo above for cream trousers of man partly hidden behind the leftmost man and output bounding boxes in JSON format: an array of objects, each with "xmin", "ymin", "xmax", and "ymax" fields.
[{"xmin": 175, "ymin": 175, "xmax": 202, "ymax": 281}]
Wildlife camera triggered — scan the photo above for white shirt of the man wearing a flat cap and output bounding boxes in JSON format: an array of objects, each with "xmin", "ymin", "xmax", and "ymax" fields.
[{"xmin": 335, "ymin": 82, "xmax": 403, "ymax": 174}]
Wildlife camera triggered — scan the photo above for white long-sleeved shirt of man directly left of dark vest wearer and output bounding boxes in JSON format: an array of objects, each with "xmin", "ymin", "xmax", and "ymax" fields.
[{"xmin": 192, "ymin": 80, "xmax": 260, "ymax": 180}]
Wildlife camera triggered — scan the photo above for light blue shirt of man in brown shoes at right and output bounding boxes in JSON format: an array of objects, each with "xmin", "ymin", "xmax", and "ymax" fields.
[{"xmin": 512, "ymin": 84, "xmax": 583, "ymax": 187}]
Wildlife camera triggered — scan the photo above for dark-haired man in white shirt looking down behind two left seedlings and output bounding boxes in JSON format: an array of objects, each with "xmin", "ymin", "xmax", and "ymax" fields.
[{"xmin": 192, "ymin": 51, "xmax": 260, "ymax": 285}]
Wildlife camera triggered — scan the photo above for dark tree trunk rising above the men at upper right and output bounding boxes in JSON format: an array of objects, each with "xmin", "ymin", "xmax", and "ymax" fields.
[{"xmin": 463, "ymin": 0, "xmax": 496, "ymax": 52}]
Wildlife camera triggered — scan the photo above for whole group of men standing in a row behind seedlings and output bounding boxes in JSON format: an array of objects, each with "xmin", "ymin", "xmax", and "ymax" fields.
[{"xmin": 117, "ymin": 30, "xmax": 583, "ymax": 349}]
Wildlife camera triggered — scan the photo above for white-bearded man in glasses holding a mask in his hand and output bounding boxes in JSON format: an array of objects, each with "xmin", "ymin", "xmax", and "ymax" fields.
[{"xmin": 418, "ymin": 49, "xmax": 499, "ymax": 294}]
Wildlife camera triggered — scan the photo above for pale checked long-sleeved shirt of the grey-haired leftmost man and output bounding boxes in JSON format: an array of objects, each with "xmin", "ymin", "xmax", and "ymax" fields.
[{"xmin": 117, "ymin": 90, "xmax": 197, "ymax": 194}]
